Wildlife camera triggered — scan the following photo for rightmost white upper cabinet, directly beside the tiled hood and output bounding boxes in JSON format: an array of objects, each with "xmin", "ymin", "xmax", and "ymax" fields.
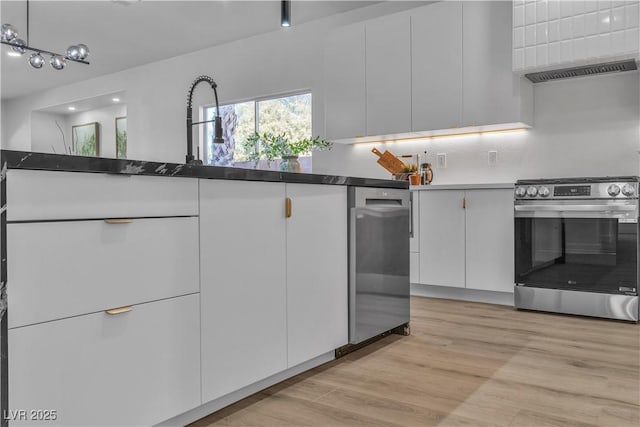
[{"xmin": 458, "ymin": 1, "xmax": 533, "ymax": 126}]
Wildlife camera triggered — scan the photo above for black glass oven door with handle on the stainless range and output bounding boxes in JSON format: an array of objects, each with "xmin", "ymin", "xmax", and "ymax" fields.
[{"xmin": 515, "ymin": 200, "xmax": 638, "ymax": 295}]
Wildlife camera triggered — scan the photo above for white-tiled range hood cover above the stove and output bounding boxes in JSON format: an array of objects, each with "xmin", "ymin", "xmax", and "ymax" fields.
[{"xmin": 512, "ymin": 0, "xmax": 640, "ymax": 74}]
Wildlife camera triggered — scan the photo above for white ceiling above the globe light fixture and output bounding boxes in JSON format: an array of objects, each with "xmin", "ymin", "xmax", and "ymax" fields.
[{"xmin": 0, "ymin": 0, "xmax": 378, "ymax": 100}]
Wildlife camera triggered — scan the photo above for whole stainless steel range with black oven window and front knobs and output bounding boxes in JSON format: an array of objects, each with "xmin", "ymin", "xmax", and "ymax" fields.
[{"xmin": 514, "ymin": 176, "xmax": 640, "ymax": 322}]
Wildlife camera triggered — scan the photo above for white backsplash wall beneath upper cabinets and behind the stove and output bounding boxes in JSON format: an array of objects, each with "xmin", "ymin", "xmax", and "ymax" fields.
[{"xmin": 313, "ymin": 71, "xmax": 640, "ymax": 184}]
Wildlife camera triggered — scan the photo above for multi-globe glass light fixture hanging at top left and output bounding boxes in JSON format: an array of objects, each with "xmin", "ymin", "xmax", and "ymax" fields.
[{"xmin": 0, "ymin": 0, "xmax": 89, "ymax": 70}]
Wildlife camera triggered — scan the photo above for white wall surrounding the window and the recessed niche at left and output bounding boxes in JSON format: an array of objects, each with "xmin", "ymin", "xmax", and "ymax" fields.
[{"xmin": 2, "ymin": 2, "xmax": 421, "ymax": 162}]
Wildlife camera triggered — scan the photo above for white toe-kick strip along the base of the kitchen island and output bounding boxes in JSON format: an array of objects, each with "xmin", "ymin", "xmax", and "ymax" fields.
[{"xmin": 156, "ymin": 351, "xmax": 335, "ymax": 427}]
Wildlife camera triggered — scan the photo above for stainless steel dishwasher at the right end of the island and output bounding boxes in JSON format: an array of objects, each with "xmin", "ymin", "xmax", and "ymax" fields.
[{"xmin": 348, "ymin": 187, "xmax": 411, "ymax": 345}]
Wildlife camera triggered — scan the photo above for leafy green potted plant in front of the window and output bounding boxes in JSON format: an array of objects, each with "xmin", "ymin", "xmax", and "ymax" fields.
[{"xmin": 242, "ymin": 132, "xmax": 333, "ymax": 172}]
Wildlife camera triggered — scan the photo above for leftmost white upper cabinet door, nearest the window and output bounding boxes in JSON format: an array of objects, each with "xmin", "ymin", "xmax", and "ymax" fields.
[{"xmin": 324, "ymin": 24, "xmax": 366, "ymax": 140}]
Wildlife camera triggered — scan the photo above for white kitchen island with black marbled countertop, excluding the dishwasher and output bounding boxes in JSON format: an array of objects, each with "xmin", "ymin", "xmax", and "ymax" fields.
[{"xmin": 1, "ymin": 151, "xmax": 408, "ymax": 425}]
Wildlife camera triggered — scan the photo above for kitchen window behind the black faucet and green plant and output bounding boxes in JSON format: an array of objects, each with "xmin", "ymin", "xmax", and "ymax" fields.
[{"xmin": 203, "ymin": 92, "xmax": 312, "ymax": 172}]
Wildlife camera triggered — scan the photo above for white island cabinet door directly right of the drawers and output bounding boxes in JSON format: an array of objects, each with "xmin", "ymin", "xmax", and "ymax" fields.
[{"xmin": 200, "ymin": 179, "xmax": 287, "ymax": 402}]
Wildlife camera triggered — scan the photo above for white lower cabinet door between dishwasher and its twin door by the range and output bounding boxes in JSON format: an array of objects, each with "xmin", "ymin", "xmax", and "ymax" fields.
[{"xmin": 420, "ymin": 190, "xmax": 465, "ymax": 288}]
